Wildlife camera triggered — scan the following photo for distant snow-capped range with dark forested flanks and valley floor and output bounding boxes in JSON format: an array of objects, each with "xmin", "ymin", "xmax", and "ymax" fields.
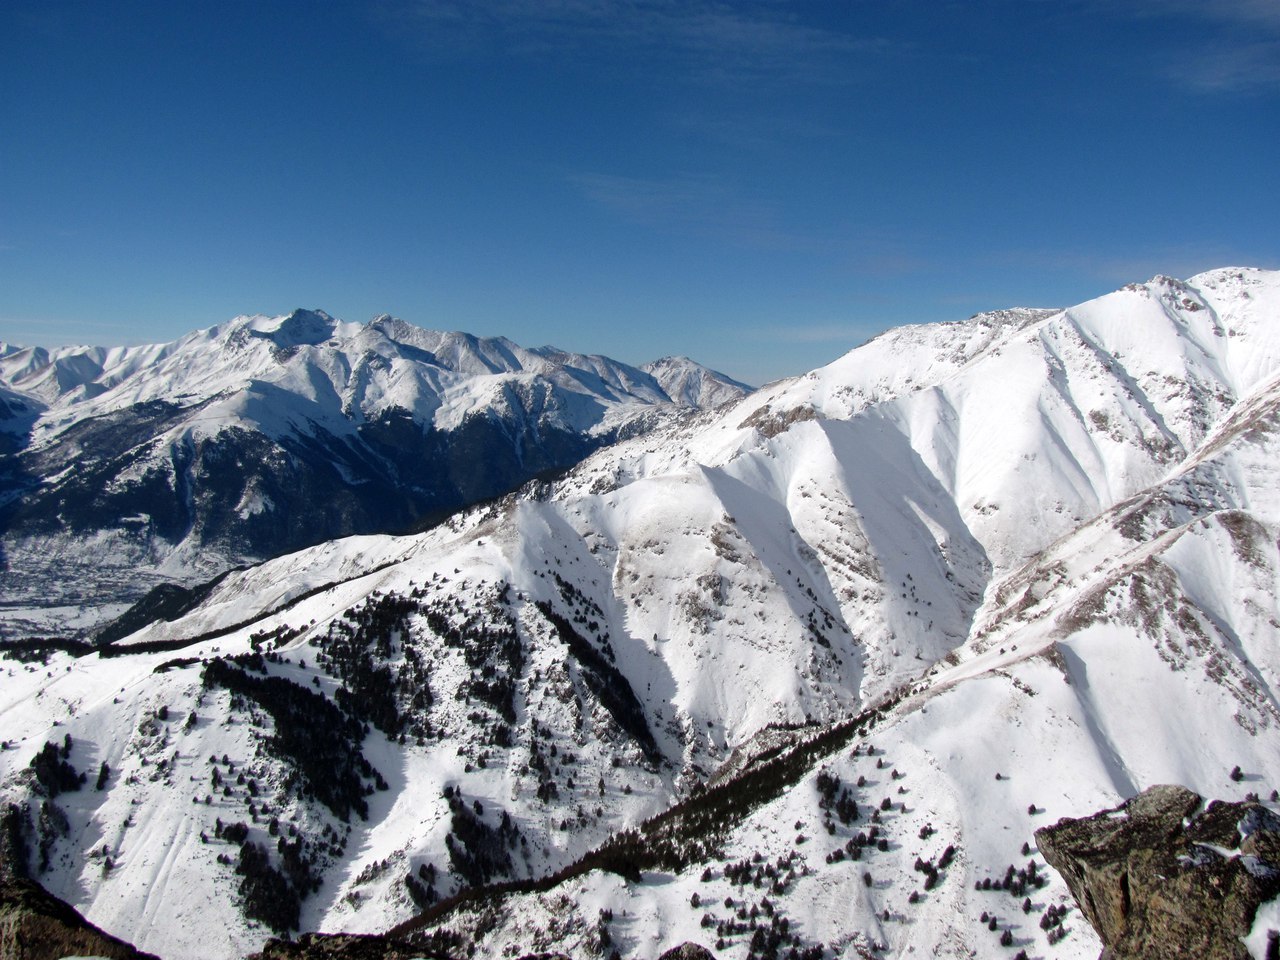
[{"xmin": 0, "ymin": 316, "xmax": 746, "ymax": 635}]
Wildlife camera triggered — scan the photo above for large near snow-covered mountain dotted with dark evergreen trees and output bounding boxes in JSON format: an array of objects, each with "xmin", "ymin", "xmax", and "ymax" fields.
[{"xmin": 0, "ymin": 269, "xmax": 1280, "ymax": 959}]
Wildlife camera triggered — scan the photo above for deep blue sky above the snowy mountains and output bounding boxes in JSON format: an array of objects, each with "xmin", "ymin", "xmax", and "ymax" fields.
[{"xmin": 0, "ymin": 0, "xmax": 1280, "ymax": 383}]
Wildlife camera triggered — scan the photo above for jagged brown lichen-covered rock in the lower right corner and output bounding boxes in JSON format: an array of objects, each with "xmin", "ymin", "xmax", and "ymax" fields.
[{"xmin": 1036, "ymin": 786, "xmax": 1280, "ymax": 960}]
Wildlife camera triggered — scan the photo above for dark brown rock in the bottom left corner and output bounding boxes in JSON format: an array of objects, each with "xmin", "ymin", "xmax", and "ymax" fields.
[{"xmin": 0, "ymin": 878, "xmax": 157, "ymax": 960}]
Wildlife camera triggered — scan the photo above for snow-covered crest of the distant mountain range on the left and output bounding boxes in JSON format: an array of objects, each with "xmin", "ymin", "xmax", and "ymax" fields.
[{"xmin": 0, "ymin": 310, "xmax": 748, "ymax": 433}]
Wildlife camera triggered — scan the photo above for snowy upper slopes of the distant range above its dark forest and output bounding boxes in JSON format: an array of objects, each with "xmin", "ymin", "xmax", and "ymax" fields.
[{"xmin": 0, "ymin": 310, "xmax": 746, "ymax": 444}]
